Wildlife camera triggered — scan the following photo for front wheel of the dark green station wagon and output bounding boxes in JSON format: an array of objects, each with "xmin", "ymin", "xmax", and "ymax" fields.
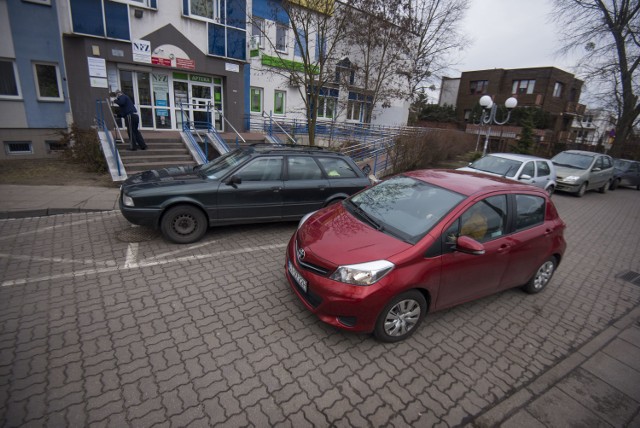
[{"xmin": 160, "ymin": 205, "xmax": 209, "ymax": 244}]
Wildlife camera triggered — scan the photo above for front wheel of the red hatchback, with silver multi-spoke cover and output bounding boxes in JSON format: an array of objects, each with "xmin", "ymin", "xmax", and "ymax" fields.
[{"xmin": 374, "ymin": 290, "xmax": 427, "ymax": 342}]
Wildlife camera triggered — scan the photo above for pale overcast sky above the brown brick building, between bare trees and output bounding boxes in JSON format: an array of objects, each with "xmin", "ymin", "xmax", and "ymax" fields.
[{"xmin": 449, "ymin": 0, "xmax": 576, "ymax": 77}]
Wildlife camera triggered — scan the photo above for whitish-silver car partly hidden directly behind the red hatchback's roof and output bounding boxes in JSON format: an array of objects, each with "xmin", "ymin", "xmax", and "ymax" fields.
[{"xmin": 458, "ymin": 153, "xmax": 556, "ymax": 195}]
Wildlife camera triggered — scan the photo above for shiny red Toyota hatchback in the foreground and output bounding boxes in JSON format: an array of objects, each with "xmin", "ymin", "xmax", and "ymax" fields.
[{"xmin": 285, "ymin": 170, "xmax": 566, "ymax": 342}]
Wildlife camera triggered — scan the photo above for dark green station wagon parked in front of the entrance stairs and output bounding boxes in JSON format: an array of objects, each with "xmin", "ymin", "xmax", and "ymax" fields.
[{"xmin": 120, "ymin": 146, "xmax": 370, "ymax": 244}]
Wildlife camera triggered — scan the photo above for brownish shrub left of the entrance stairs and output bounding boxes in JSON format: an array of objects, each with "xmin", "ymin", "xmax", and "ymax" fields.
[{"xmin": 59, "ymin": 124, "xmax": 107, "ymax": 173}]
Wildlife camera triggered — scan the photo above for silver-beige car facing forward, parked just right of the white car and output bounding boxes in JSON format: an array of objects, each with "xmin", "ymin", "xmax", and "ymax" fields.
[{"xmin": 551, "ymin": 150, "xmax": 614, "ymax": 197}]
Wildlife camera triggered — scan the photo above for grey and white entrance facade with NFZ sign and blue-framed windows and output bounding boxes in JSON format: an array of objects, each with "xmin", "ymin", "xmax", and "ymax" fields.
[{"xmin": 60, "ymin": 0, "xmax": 247, "ymax": 131}]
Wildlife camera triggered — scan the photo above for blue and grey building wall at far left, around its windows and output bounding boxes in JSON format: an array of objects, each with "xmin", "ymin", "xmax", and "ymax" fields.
[{"xmin": 0, "ymin": 0, "xmax": 70, "ymax": 159}]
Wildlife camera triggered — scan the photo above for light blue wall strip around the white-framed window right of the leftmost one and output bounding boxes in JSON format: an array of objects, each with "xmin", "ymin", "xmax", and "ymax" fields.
[{"xmin": 7, "ymin": 0, "xmax": 70, "ymax": 129}]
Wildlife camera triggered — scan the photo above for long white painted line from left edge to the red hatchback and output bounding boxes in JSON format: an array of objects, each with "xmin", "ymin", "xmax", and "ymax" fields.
[{"xmin": 0, "ymin": 244, "xmax": 287, "ymax": 288}]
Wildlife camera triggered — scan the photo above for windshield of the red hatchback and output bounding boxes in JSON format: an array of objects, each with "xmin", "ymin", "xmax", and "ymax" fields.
[{"xmin": 345, "ymin": 176, "xmax": 464, "ymax": 244}]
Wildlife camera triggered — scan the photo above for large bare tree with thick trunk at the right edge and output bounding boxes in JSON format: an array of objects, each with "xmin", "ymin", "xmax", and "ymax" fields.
[{"xmin": 554, "ymin": 0, "xmax": 640, "ymax": 156}]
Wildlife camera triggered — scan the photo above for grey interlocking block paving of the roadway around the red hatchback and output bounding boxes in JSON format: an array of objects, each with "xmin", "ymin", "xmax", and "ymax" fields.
[{"xmin": 0, "ymin": 189, "xmax": 640, "ymax": 427}]
